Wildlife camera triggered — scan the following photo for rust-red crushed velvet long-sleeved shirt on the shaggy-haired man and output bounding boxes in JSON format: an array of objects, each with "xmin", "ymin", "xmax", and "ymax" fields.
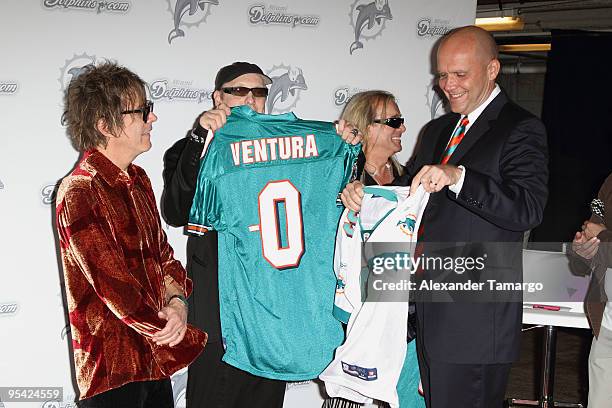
[{"xmin": 56, "ymin": 151, "xmax": 207, "ymax": 399}]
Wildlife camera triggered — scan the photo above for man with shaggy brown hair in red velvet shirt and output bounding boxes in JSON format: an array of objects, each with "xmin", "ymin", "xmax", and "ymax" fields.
[{"xmin": 56, "ymin": 63, "xmax": 207, "ymax": 408}]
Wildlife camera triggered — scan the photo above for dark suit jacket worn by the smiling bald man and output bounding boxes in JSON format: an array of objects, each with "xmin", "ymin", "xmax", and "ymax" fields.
[{"xmin": 397, "ymin": 92, "xmax": 548, "ymax": 364}]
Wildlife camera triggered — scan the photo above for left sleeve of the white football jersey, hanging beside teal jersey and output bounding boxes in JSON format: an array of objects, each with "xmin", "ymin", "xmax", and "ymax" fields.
[{"xmin": 333, "ymin": 209, "xmax": 361, "ymax": 324}]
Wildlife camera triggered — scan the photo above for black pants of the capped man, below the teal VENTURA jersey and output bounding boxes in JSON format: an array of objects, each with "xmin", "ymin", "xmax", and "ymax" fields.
[{"xmin": 186, "ymin": 342, "xmax": 285, "ymax": 408}]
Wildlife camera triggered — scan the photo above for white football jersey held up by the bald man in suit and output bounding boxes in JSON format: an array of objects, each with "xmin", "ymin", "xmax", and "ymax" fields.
[{"xmin": 319, "ymin": 186, "xmax": 429, "ymax": 407}]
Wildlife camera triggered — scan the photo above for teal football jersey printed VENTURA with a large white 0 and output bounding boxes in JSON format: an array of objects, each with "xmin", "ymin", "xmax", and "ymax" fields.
[{"xmin": 188, "ymin": 106, "xmax": 360, "ymax": 381}]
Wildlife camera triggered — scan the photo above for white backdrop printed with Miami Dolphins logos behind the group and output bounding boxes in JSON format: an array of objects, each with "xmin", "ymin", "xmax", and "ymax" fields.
[{"xmin": 0, "ymin": 0, "xmax": 476, "ymax": 408}]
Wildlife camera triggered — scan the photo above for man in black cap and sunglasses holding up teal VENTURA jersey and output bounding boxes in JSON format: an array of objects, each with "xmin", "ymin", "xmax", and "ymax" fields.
[{"xmin": 162, "ymin": 62, "xmax": 285, "ymax": 408}]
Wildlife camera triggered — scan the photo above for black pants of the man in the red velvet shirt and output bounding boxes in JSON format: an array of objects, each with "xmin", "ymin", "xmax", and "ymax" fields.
[{"xmin": 77, "ymin": 378, "xmax": 174, "ymax": 408}]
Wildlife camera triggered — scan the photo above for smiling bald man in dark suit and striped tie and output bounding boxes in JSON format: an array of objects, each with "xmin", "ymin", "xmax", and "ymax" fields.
[{"xmin": 342, "ymin": 26, "xmax": 548, "ymax": 408}]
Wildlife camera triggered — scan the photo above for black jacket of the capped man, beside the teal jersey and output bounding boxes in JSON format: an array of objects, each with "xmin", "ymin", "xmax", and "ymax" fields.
[{"xmin": 161, "ymin": 135, "xmax": 221, "ymax": 343}]
